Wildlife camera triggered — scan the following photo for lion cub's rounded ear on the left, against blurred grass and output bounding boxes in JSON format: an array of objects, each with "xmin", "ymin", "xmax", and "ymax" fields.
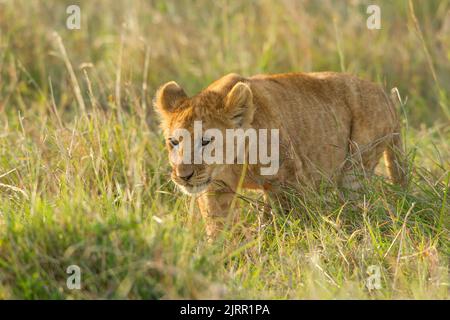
[{"xmin": 153, "ymin": 81, "xmax": 187, "ymax": 116}]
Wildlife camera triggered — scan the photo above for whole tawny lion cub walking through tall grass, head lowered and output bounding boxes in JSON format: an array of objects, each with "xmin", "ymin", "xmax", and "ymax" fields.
[{"xmin": 154, "ymin": 72, "xmax": 405, "ymax": 236}]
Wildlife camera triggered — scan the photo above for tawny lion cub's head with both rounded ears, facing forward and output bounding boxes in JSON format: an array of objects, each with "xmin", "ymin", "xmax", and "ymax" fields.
[{"xmin": 154, "ymin": 81, "xmax": 254, "ymax": 194}]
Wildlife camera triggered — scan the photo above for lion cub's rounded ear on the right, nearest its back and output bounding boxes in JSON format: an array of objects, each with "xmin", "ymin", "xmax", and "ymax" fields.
[{"xmin": 225, "ymin": 82, "xmax": 255, "ymax": 127}]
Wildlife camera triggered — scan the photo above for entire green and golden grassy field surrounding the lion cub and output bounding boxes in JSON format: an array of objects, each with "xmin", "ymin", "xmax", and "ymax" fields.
[{"xmin": 0, "ymin": 0, "xmax": 450, "ymax": 299}]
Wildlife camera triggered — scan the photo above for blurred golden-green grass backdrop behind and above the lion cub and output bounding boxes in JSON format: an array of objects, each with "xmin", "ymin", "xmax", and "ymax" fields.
[{"xmin": 0, "ymin": 0, "xmax": 450, "ymax": 126}]
